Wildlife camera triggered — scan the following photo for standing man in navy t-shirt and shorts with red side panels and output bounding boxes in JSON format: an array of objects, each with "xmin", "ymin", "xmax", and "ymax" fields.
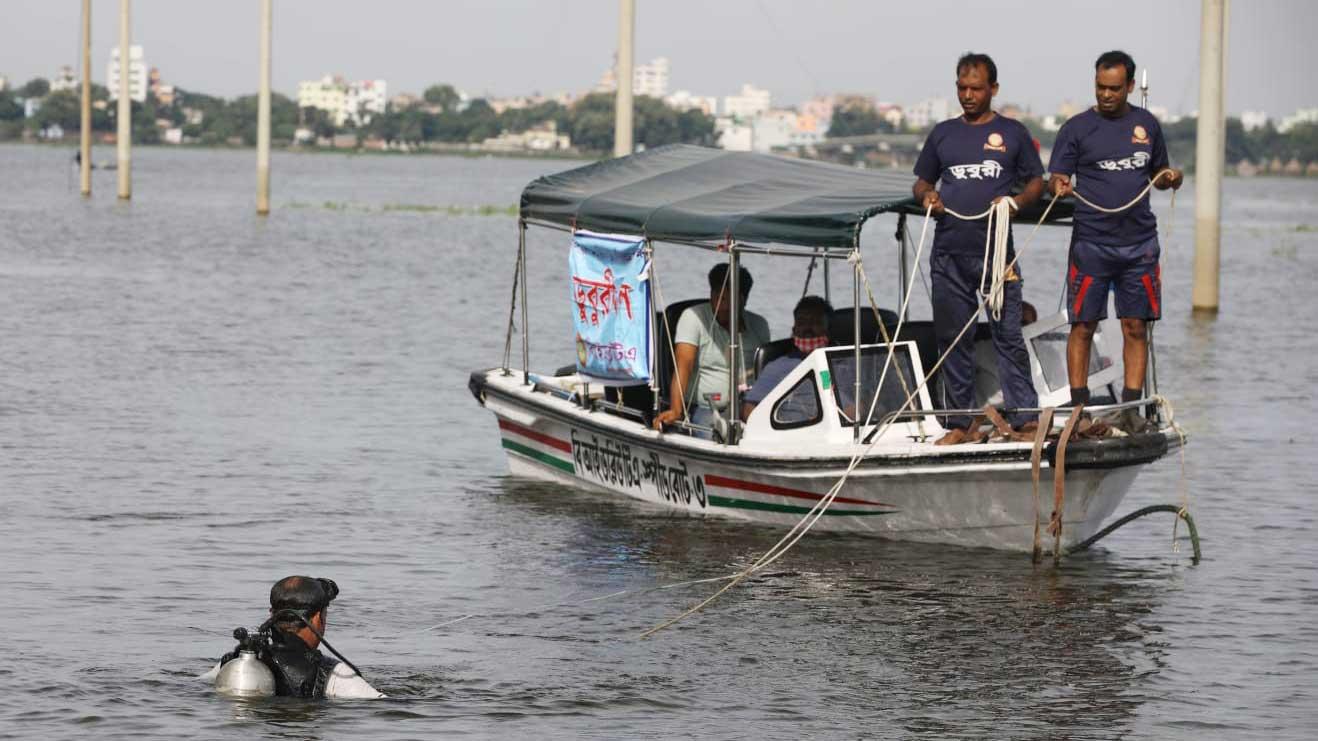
[{"xmin": 1048, "ymin": 51, "xmax": 1184, "ymax": 431}]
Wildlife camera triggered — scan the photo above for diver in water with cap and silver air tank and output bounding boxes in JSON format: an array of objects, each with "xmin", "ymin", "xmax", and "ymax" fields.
[{"xmin": 202, "ymin": 576, "xmax": 385, "ymax": 699}]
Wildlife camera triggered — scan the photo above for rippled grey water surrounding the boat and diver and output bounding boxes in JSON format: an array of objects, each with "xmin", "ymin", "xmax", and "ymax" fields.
[{"xmin": 0, "ymin": 141, "xmax": 1318, "ymax": 738}]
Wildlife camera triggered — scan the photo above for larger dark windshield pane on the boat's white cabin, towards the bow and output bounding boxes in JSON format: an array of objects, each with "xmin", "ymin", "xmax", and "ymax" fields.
[{"xmin": 824, "ymin": 345, "xmax": 923, "ymax": 427}]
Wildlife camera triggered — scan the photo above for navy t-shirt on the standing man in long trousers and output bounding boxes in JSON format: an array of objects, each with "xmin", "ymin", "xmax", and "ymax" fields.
[{"xmin": 915, "ymin": 113, "xmax": 1044, "ymax": 254}]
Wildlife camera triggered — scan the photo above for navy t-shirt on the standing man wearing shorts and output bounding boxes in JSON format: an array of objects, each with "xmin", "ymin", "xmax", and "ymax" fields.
[{"xmin": 1048, "ymin": 105, "xmax": 1168, "ymax": 247}]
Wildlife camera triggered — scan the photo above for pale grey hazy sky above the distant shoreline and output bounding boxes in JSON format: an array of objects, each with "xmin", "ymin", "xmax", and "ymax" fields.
[{"xmin": 0, "ymin": 0, "xmax": 1318, "ymax": 117}]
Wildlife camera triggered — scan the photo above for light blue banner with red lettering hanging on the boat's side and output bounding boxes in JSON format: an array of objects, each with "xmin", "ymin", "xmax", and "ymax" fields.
[{"xmin": 568, "ymin": 232, "xmax": 650, "ymax": 386}]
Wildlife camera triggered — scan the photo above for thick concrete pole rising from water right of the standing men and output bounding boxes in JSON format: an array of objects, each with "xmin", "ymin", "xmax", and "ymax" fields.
[{"xmin": 1191, "ymin": 0, "xmax": 1226, "ymax": 312}]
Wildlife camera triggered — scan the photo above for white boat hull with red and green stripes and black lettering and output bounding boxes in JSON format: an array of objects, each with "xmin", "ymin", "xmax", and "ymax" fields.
[{"xmin": 473, "ymin": 376, "xmax": 1166, "ymax": 551}]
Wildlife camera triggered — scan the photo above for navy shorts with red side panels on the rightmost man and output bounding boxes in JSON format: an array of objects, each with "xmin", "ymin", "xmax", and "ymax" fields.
[{"xmin": 1066, "ymin": 236, "xmax": 1162, "ymax": 323}]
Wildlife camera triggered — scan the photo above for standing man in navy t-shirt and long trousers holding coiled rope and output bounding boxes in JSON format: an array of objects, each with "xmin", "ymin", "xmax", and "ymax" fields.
[{"xmin": 912, "ymin": 54, "xmax": 1044, "ymax": 446}]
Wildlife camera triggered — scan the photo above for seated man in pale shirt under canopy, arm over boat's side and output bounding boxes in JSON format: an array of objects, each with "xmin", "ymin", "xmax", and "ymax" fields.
[{"xmin": 654, "ymin": 262, "xmax": 768, "ymax": 438}]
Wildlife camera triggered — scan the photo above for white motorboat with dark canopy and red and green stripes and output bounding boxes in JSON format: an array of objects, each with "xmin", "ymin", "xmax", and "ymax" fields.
[{"xmin": 469, "ymin": 146, "xmax": 1182, "ymax": 551}]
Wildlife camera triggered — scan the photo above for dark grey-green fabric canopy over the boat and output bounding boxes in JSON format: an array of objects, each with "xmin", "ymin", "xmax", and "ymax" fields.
[{"xmin": 521, "ymin": 144, "xmax": 1070, "ymax": 249}]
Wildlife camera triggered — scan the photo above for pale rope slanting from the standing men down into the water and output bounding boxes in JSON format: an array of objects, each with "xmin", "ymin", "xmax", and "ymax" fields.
[{"xmin": 641, "ymin": 200, "xmax": 1056, "ymax": 638}]
